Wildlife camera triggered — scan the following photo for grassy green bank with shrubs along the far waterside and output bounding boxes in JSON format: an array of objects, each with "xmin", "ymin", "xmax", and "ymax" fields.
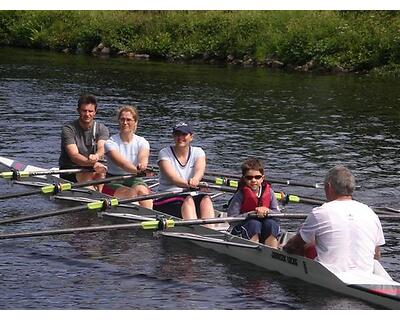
[{"xmin": 0, "ymin": 11, "xmax": 400, "ymax": 75}]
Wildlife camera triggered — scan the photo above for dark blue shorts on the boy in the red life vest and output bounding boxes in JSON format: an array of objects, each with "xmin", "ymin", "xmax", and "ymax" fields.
[{"xmin": 232, "ymin": 218, "xmax": 281, "ymax": 243}]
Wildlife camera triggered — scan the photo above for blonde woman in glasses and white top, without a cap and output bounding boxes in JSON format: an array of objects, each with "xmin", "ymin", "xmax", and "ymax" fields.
[{"xmin": 103, "ymin": 106, "xmax": 153, "ymax": 209}]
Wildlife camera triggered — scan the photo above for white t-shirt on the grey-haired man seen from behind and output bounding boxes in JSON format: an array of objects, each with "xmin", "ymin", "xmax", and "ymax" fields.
[{"xmin": 299, "ymin": 200, "xmax": 385, "ymax": 273}]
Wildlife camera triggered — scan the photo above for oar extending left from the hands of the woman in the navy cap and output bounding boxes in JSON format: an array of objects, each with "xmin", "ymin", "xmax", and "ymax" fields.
[{"xmin": 0, "ymin": 190, "xmax": 187, "ymax": 225}]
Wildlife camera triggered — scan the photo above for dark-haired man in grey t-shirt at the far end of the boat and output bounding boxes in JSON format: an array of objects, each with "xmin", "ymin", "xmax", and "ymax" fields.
[{"xmin": 59, "ymin": 95, "xmax": 109, "ymax": 182}]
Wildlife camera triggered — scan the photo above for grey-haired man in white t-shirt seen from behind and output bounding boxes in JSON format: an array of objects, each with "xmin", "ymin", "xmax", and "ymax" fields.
[{"xmin": 284, "ymin": 166, "xmax": 385, "ymax": 273}]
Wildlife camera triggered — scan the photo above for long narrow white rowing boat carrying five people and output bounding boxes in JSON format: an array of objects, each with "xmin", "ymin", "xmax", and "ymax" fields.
[{"xmin": 0, "ymin": 157, "xmax": 400, "ymax": 309}]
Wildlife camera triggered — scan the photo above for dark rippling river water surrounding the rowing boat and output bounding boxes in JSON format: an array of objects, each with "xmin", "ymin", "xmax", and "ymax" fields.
[{"xmin": 0, "ymin": 48, "xmax": 400, "ymax": 310}]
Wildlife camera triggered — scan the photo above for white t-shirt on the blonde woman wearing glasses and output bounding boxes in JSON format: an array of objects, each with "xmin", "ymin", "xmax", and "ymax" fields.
[{"xmin": 104, "ymin": 133, "xmax": 150, "ymax": 175}]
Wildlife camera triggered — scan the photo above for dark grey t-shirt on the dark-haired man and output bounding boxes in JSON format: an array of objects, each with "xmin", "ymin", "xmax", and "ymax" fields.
[{"xmin": 58, "ymin": 119, "xmax": 109, "ymax": 169}]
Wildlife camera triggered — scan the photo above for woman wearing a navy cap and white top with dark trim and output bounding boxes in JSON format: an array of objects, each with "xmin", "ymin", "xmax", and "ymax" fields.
[{"xmin": 154, "ymin": 122, "xmax": 214, "ymax": 219}]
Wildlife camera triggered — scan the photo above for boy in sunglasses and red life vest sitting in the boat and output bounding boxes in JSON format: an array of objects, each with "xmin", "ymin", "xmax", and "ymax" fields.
[{"xmin": 228, "ymin": 158, "xmax": 280, "ymax": 248}]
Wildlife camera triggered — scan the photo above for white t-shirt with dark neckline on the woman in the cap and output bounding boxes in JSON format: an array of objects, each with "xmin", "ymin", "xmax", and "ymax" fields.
[{"xmin": 157, "ymin": 146, "xmax": 206, "ymax": 191}]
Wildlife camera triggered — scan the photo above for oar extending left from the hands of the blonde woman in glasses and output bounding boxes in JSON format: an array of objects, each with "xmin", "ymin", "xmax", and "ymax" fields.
[{"xmin": 0, "ymin": 174, "xmax": 141, "ymax": 200}]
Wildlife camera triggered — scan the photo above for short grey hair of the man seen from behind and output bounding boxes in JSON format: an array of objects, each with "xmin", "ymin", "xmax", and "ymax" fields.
[{"xmin": 325, "ymin": 165, "xmax": 356, "ymax": 196}]
